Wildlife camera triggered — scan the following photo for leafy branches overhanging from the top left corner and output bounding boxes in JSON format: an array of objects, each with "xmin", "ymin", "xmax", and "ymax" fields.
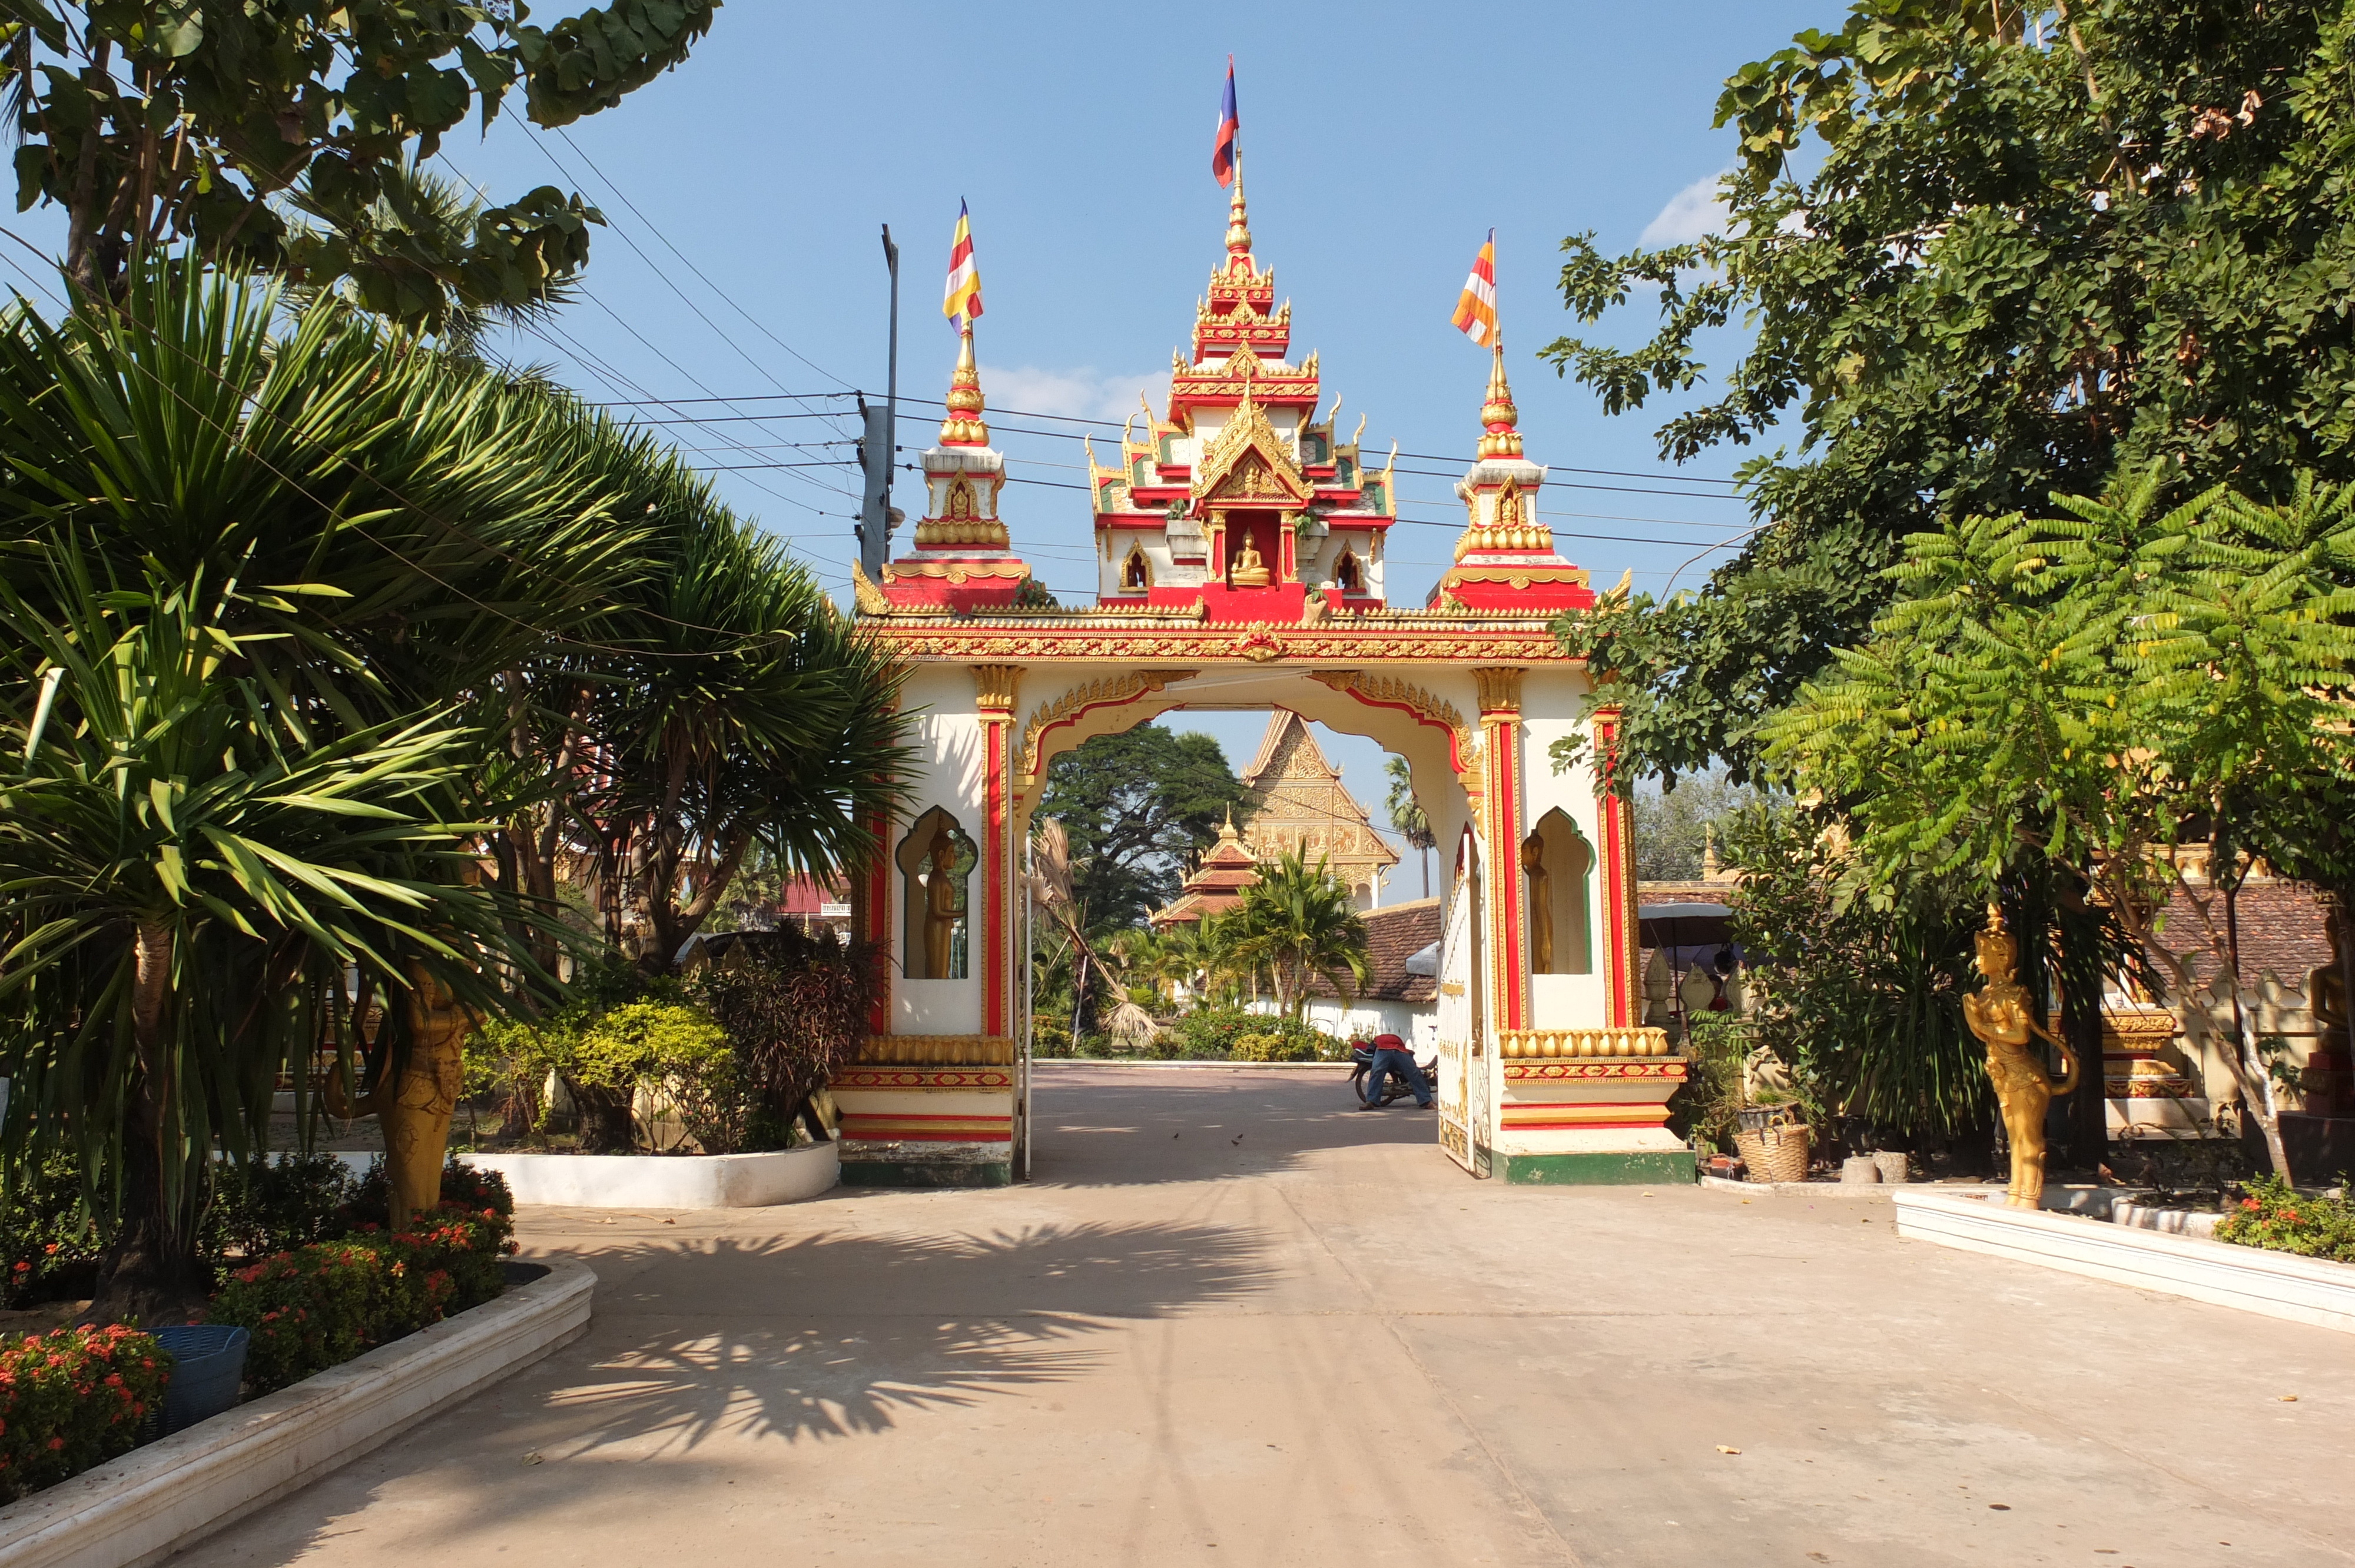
[{"xmin": 0, "ymin": 0, "xmax": 716, "ymax": 327}]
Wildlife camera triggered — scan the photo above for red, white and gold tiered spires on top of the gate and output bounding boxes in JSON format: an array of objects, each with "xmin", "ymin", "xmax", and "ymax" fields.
[{"xmin": 876, "ymin": 150, "xmax": 1594, "ymax": 626}]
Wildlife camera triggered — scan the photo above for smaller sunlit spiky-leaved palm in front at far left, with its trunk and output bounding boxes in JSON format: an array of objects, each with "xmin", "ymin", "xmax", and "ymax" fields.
[{"xmin": 0, "ymin": 549, "xmax": 539, "ymax": 1323}]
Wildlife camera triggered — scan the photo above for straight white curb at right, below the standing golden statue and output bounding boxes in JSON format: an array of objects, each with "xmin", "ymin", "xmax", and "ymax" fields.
[{"xmin": 1889, "ymin": 1187, "xmax": 2355, "ymax": 1333}]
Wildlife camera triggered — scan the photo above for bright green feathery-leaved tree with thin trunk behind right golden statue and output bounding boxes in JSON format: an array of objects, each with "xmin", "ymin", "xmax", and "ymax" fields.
[{"xmin": 1764, "ymin": 473, "xmax": 2355, "ymax": 1177}]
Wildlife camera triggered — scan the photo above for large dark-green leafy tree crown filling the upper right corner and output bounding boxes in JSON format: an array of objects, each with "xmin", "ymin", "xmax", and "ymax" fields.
[{"xmin": 1545, "ymin": 0, "xmax": 2355, "ymax": 779}]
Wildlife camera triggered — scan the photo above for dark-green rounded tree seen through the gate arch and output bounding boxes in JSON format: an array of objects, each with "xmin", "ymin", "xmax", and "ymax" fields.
[{"xmin": 1039, "ymin": 725, "xmax": 1251, "ymax": 930}]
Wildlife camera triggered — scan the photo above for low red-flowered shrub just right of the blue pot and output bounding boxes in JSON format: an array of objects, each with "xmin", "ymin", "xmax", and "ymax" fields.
[{"xmin": 210, "ymin": 1203, "xmax": 513, "ymax": 1394}]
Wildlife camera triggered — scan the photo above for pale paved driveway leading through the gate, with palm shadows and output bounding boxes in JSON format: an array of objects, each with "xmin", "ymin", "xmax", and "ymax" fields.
[{"xmin": 179, "ymin": 1067, "xmax": 2355, "ymax": 1568}]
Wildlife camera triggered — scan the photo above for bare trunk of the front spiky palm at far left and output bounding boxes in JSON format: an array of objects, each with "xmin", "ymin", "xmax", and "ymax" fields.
[{"xmin": 82, "ymin": 921, "xmax": 207, "ymax": 1328}]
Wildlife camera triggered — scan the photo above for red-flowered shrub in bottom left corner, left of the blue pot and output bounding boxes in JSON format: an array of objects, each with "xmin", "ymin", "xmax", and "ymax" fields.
[{"xmin": 0, "ymin": 1326, "xmax": 172, "ymax": 1502}]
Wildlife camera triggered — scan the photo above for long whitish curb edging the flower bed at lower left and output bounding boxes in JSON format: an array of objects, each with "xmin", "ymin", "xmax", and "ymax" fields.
[{"xmin": 0, "ymin": 1260, "xmax": 596, "ymax": 1568}]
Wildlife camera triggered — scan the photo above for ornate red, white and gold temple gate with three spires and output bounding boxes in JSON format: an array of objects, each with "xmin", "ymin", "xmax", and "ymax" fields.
[{"xmin": 834, "ymin": 155, "xmax": 1691, "ymax": 1184}]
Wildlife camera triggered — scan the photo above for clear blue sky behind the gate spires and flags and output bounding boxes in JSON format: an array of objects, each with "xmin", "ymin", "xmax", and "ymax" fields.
[{"xmin": 12, "ymin": 0, "xmax": 1844, "ymax": 881}]
